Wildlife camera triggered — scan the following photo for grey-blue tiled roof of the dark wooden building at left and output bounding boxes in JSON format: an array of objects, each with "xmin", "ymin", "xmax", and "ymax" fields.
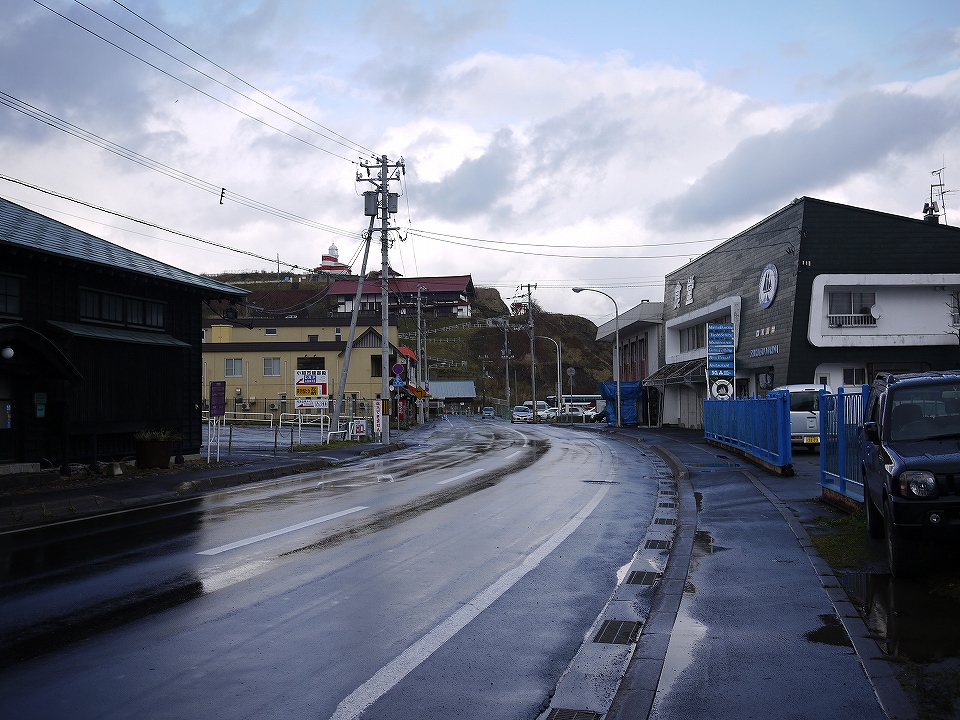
[{"xmin": 0, "ymin": 198, "xmax": 247, "ymax": 297}]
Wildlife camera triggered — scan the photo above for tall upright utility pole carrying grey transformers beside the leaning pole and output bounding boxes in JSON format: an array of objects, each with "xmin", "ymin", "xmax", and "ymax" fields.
[{"xmin": 357, "ymin": 155, "xmax": 407, "ymax": 445}]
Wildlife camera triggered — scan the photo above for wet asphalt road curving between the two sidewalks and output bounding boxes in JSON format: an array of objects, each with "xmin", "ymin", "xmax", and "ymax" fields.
[{"xmin": 0, "ymin": 418, "xmax": 660, "ymax": 718}]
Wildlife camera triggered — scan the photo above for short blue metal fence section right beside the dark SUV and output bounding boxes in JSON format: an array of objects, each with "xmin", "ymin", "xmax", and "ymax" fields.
[{"xmin": 820, "ymin": 385, "xmax": 870, "ymax": 502}]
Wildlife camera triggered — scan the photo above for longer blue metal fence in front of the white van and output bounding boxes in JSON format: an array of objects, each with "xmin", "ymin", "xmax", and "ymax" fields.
[{"xmin": 703, "ymin": 392, "xmax": 793, "ymax": 467}]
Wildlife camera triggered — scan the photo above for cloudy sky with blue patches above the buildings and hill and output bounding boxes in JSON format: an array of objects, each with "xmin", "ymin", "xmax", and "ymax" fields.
[{"xmin": 0, "ymin": 0, "xmax": 960, "ymax": 323}]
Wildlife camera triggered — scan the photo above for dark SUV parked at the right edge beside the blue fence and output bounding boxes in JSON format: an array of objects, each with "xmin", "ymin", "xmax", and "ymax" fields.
[{"xmin": 861, "ymin": 371, "xmax": 960, "ymax": 576}]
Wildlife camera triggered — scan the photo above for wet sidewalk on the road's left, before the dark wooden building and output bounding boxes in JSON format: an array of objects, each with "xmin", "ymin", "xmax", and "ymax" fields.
[{"xmin": 0, "ymin": 421, "xmax": 434, "ymax": 530}]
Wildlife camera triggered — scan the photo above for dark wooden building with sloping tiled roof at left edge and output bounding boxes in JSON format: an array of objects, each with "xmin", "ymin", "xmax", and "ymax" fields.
[{"xmin": 0, "ymin": 199, "xmax": 246, "ymax": 465}]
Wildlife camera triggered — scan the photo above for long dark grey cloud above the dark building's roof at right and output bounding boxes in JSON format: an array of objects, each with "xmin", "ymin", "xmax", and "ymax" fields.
[{"xmin": 651, "ymin": 91, "xmax": 960, "ymax": 228}]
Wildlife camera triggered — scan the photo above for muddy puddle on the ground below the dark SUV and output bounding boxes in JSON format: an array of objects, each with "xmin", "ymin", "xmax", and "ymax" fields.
[{"xmin": 840, "ymin": 572, "xmax": 960, "ymax": 663}]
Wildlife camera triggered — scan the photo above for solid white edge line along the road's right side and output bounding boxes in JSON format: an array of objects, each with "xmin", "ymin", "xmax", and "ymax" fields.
[{"xmin": 330, "ymin": 486, "xmax": 608, "ymax": 720}]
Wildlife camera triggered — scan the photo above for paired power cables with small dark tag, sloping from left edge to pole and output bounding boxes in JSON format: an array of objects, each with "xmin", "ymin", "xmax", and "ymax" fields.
[{"xmin": 0, "ymin": 90, "xmax": 359, "ymax": 238}]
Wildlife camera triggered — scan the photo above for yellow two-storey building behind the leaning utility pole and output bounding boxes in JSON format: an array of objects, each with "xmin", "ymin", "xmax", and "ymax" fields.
[{"xmin": 202, "ymin": 318, "xmax": 406, "ymax": 417}]
